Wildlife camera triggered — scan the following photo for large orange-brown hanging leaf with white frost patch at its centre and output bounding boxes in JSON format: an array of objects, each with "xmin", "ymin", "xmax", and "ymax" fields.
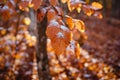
[{"xmin": 46, "ymin": 22, "xmax": 71, "ymax": 55}]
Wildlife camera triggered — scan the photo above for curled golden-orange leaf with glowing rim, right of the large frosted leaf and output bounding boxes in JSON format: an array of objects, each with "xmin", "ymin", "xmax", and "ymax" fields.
[{"xmin": 74, "ymin": 19, "xmax": 85, "ymax": 32}]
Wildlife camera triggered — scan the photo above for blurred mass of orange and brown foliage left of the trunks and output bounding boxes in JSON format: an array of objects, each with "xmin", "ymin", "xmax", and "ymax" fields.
[{"xmin": 0, "ymin": 0, "xmax": 36, "ymax": 80}]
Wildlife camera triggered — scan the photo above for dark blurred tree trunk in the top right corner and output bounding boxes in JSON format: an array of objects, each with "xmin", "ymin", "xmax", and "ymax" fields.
[{"xmin": 112, "ymin": 0, "xmax": 120, "ymax": 19}]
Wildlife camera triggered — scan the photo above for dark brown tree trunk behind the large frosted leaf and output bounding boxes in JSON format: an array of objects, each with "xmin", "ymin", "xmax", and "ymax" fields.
[{"xmin": 36, "ymin": 13, "xmax": 51, "ymax": 80}]
